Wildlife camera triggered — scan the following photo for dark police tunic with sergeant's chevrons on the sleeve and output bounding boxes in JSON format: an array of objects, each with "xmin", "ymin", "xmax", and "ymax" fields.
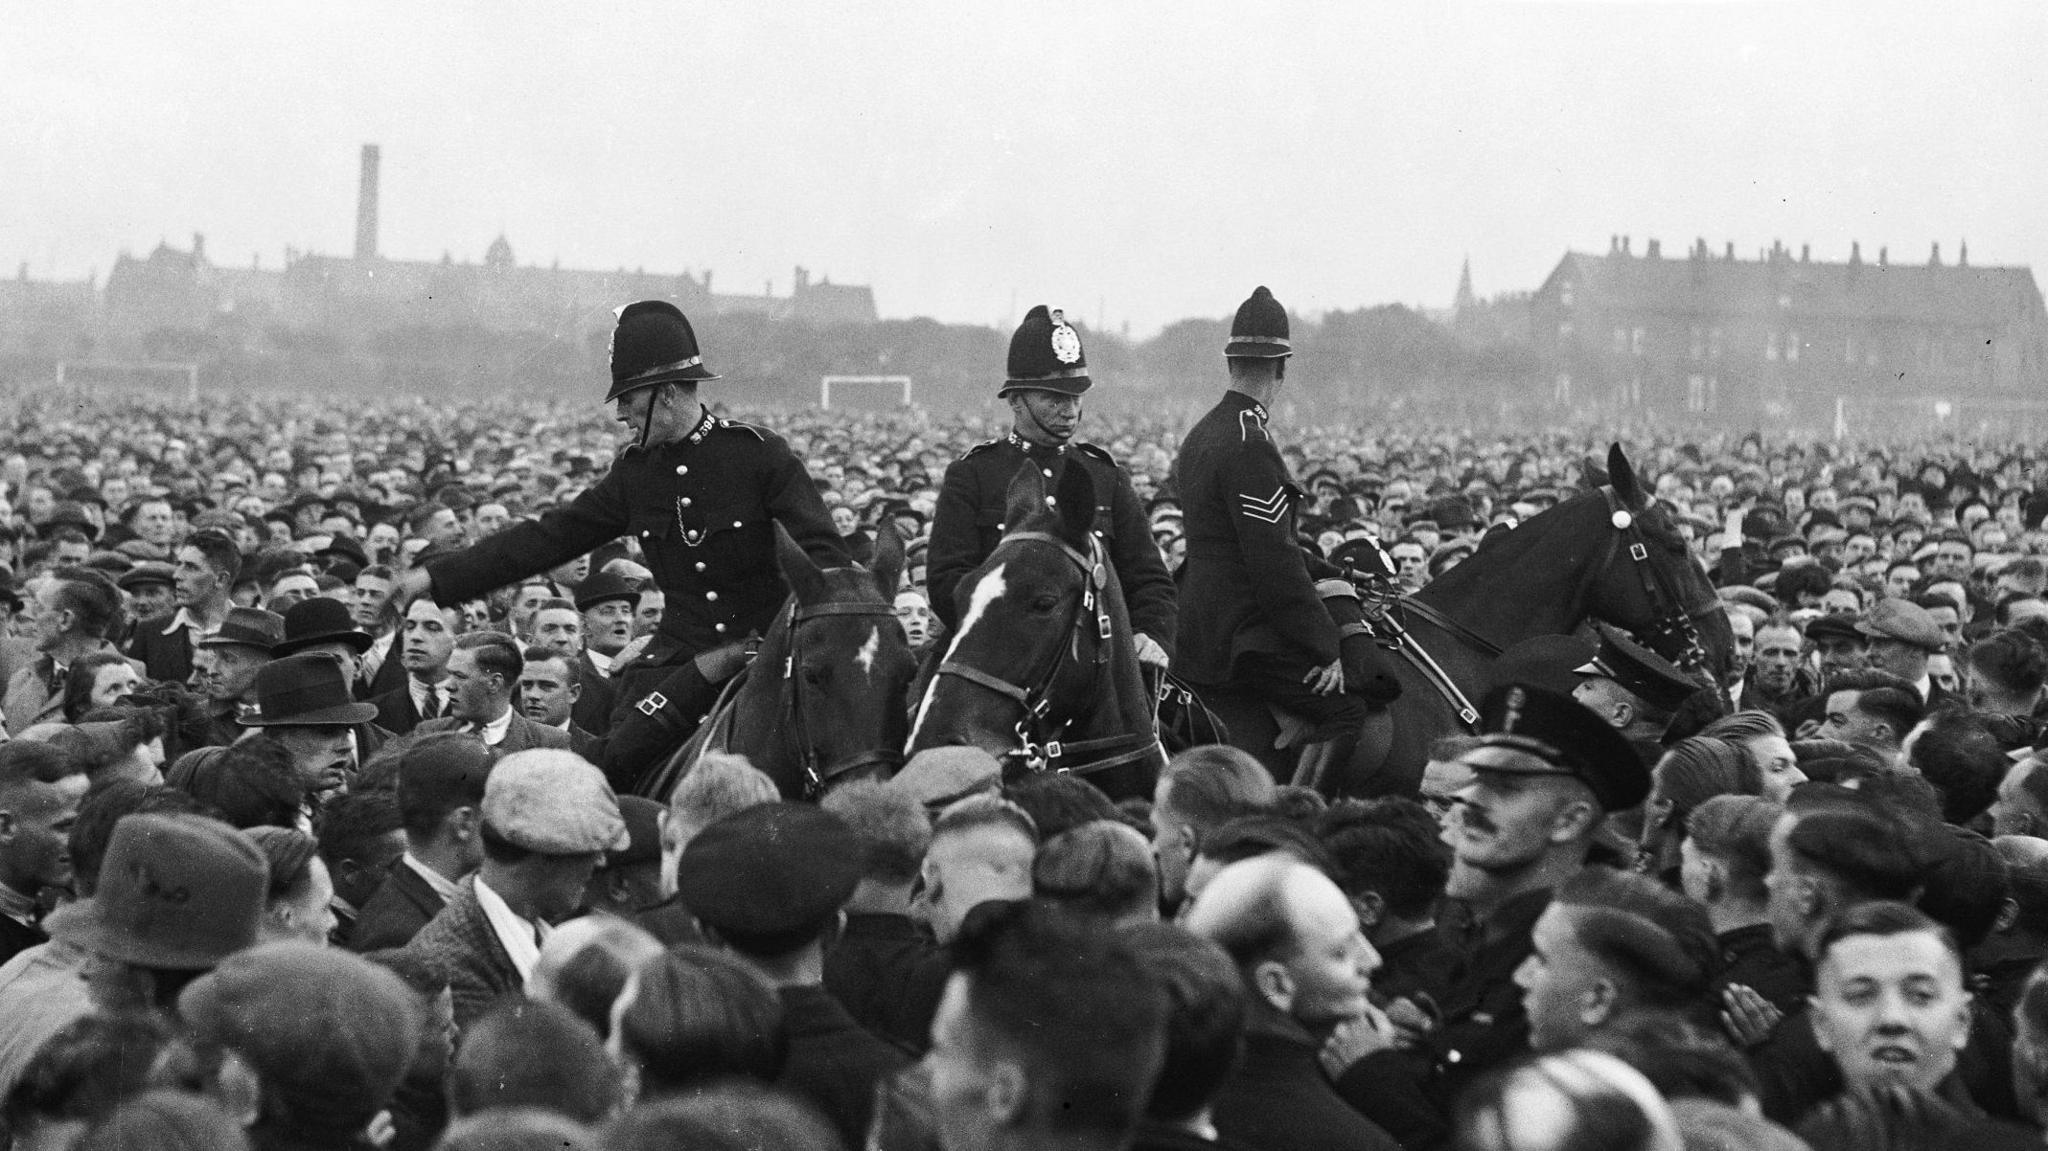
[{"xmin": 1174, "ymin": 391, "xmax": 1337, "ymax": 686}]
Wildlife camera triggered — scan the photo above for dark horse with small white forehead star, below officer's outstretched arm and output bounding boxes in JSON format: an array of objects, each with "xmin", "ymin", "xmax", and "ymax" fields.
[{"xmin": 633, "ymin": 526, "xmax": 918, "ymax": 803}]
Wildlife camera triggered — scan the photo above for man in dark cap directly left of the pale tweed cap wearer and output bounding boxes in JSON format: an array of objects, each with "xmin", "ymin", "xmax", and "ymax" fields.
[{"xmin": 348, "ymin": 735, "xmax": 498, "ymax": 952}]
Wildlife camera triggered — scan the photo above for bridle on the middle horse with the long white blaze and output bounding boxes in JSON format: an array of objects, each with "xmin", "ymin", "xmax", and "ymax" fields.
[{"xmin": 938, "ymin": 532, "xmax": 1165, "ymax": 772}]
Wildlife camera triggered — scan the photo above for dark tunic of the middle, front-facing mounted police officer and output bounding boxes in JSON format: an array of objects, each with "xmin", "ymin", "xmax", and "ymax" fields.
[{"xmin": 926, "ymin": 432, "xmax": 1178, "ymax": 655}]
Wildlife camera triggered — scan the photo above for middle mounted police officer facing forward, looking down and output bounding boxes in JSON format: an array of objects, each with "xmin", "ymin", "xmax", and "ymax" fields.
[{"xmin": 926, "ymin": 303, "xmax": 1178, "ymax": 668}]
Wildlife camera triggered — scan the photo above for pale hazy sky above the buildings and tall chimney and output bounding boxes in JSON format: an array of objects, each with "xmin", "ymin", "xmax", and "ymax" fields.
[{"xmin": 0, "ymin": 0, "xmax": 2048, "ymax": 336}]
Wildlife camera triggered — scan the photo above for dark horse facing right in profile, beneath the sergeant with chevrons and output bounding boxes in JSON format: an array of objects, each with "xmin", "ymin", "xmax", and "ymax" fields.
[{"xmin": 1210, "ymin": 444, "xmax": 1735, "ymax": 795}]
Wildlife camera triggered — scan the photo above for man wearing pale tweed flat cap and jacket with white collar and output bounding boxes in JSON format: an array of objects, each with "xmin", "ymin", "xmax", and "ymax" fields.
[{"xmin": 406, "ymin": 750, "xmax": 631, "ymax": 1028}]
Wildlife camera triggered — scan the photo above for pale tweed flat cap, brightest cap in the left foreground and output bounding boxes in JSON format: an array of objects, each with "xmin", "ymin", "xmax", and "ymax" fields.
[{"xmin": 483, "ymin": 748, "xmax": 633, "ymax": 856}]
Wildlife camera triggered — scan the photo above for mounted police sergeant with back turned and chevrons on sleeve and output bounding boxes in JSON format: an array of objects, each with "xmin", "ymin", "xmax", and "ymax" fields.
[{"xmin": 1174, "ymin": 287, "xmax": 1366, "ymax": 766}]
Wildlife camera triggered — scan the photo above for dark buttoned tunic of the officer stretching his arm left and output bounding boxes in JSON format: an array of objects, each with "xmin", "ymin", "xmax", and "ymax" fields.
[{"xmin": 430, "ymin": 410, "xmax": 848, "ymax": 666}]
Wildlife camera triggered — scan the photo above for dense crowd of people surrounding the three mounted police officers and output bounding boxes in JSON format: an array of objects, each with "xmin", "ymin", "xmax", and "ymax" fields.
[{"xmin": 0, "ymin": 344, "xmax": 2048, "ymax": 1151}]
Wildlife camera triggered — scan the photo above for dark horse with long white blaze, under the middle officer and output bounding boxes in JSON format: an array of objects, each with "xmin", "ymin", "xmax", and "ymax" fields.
[{"xmin": 909, "ymin": 456, "xmax": 1165, "ymax": 799}]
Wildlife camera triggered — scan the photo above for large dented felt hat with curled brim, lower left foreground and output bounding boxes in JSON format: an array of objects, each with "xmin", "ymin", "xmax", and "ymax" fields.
[{"xmin": 45, "ymin": 813, "xmax": 270, "ymax": 971}]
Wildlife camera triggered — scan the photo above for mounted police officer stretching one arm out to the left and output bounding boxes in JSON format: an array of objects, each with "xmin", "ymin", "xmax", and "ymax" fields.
[{"xmin": 403, "ymin": 299, "xmax": 850, "ymax": 765}]
